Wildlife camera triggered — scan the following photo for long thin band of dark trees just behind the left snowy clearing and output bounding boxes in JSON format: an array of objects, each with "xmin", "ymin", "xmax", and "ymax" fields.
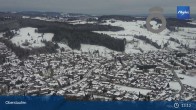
[{"xmin": 19, "ymin": 19, "xmax": 124, "ymax": 31}]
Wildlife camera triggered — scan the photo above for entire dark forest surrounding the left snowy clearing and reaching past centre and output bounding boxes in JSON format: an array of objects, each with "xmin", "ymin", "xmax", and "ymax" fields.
[{"xmin": 0, "ymin": 19, "xmax": 125, "ymax": 58}]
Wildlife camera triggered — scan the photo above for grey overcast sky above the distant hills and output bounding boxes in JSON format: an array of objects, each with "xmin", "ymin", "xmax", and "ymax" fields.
[{"xmin": 0, "ymin": 0, "xmax": 196, "ymax": 15}]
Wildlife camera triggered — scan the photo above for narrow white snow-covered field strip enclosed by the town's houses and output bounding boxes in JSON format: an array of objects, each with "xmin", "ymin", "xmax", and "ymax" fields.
[{"xmin": 115, "ymin": 85, "xmax": 151, "ymax": 95}]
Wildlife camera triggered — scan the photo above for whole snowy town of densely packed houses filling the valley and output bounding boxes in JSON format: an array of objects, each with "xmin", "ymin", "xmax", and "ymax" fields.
[{"xmin": 0, "ymin": 43, "xmax": 196, "ymax": 100}]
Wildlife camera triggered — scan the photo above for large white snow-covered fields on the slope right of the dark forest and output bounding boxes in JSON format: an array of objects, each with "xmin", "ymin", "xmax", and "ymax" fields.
[{"xmin": 92, "ymin": 20, "xmax": 196, "ymax": 53}]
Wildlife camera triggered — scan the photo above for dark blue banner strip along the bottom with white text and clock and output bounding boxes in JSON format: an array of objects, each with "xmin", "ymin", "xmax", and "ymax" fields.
[{"xmin": 0, "ymin": 96, "xmax": 196, "ymax": 110}]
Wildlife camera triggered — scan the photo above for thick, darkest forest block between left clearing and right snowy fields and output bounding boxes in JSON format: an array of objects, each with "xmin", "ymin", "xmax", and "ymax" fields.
[{"xmin": 52, "ymin": 30, "xmax": 125, "ymax": 52}]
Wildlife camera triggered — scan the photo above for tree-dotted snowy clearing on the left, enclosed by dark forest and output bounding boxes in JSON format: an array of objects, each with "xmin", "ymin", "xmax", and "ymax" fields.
[{"xmin": 11, "ymin": 27, "xmax": 54, "ymax": 49}]
